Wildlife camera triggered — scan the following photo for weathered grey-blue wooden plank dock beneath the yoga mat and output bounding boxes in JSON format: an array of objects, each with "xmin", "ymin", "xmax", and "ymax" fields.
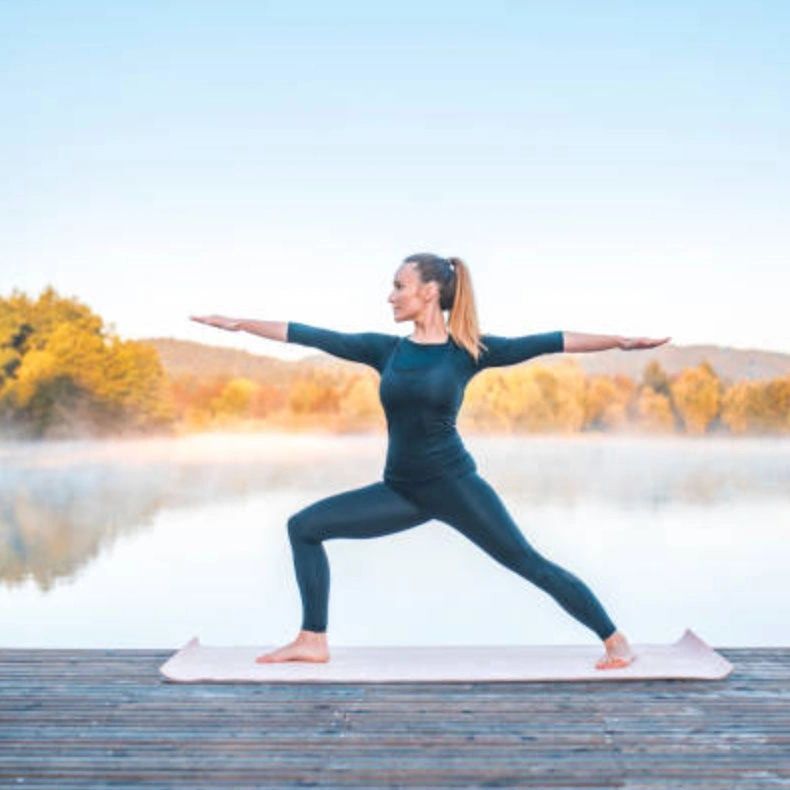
[{"xmin": 0, "ymin": 647, "xmax": 790, "ymax": 790}]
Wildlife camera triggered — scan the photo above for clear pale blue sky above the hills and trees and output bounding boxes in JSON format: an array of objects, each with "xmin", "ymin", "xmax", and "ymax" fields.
[{"xmin": 0, "ymin": 0, "xmax": 790, "ymax": 358}]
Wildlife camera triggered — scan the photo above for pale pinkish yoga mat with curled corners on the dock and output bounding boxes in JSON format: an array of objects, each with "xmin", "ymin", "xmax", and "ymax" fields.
[{"xmin": 159, "ymin": 628, "xmax": 733, "ymax": 683}]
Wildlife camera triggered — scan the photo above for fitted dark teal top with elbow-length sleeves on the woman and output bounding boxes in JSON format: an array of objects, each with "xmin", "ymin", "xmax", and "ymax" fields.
[{"xmin": 287, "ymin": 321, "xmax": 565, "ymax": 484}]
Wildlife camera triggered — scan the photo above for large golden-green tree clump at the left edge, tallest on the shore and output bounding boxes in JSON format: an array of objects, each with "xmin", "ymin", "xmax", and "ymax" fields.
[{"xmin": 0, "ymin": 286, "xmax": 174, "ymax": 437}]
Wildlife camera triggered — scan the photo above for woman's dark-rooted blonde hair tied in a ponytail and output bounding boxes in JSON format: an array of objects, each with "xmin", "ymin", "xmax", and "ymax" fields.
[{"xmin": 404, "ymin": 252, "xmax": 486, "ymax": 362}]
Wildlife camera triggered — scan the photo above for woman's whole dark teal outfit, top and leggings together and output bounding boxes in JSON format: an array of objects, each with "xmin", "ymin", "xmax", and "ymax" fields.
[{"xmin": 287, "ymin": 322, "xmax": 616, "ymax": 639}]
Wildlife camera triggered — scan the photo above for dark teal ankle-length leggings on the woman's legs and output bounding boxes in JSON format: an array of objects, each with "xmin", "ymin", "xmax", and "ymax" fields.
[{"xmin": 288, "ymin": 471, "xmax": 616, "ymax": 639}]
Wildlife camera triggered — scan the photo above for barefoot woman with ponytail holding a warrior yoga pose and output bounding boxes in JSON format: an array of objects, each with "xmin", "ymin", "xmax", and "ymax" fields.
[{"xmin": 191, "ymin": 253, "xmax": 669, "ymax": 669}]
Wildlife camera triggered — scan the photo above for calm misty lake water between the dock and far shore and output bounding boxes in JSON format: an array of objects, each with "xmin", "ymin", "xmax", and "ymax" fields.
[{"xmin": 0, "ymin": 434, "xmax": 790, "ymax": 648}]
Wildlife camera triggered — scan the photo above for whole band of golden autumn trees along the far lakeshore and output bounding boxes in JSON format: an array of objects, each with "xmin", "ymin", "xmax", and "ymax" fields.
[{"xmin": 0, "ymin": 286, "xmax": 790, "ymax": 439}]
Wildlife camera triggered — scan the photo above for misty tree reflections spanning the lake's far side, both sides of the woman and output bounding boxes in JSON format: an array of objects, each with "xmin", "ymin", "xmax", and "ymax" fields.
[{"xmin": 0, "ymin": 434, "xmax": 790, "ymax": 590}]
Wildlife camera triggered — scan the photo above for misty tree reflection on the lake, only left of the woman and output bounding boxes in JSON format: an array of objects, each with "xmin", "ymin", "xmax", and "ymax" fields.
[{"xmin": 0, "ymin": 434, "xmax": 380, "ymax": 590}]
